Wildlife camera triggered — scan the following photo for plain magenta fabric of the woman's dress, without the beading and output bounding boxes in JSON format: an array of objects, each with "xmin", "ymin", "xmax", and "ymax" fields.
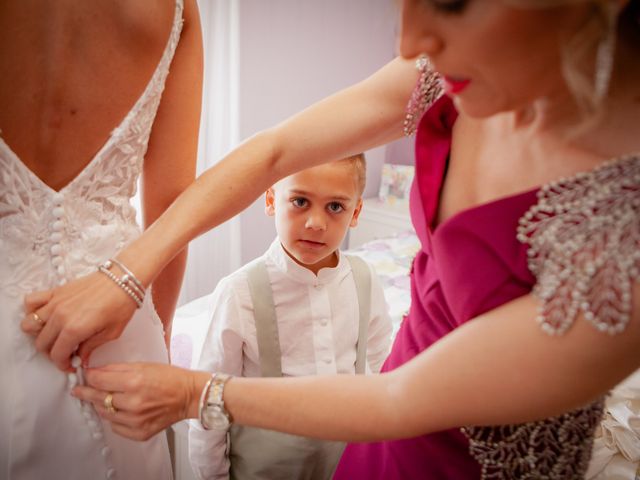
[{"xmin": 334, "ymin": 96, "xmax": 536, "ymax": 480}]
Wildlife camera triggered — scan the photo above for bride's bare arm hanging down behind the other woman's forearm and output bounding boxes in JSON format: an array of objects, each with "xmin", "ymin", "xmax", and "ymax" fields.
[{"xmin": 140, "ymin": 0, "xmax": 203, "ymax": 345}]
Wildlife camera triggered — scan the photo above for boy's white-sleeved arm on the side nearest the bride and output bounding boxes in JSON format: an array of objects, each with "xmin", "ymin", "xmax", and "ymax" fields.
[{"xmin": 189, "ymin": 277, "xmax": 246, "ymax": 479}]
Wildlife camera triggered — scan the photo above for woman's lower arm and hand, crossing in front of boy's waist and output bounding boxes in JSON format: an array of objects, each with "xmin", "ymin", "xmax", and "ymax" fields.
[{"xmin": 75, "ymin": 284, "xmax": 640, "ymax": 441}]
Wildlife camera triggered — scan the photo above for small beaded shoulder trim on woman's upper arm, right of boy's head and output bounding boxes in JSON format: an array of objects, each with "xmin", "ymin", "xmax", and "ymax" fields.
[{"xmin": 403, "ymin": 55, "xmax": 443, "ymax": 137}]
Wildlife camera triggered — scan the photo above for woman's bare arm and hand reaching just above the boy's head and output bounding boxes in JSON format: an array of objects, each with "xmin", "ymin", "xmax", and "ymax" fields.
[{"xmin": 23, "ymin": 58, "xmax": 418, "ymax": 369}]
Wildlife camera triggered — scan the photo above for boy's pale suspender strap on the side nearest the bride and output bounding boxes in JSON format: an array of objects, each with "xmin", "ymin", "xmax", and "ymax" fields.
[{"xmin": 247, "ymin": 260, "xmax": 282, "ymax": 377}]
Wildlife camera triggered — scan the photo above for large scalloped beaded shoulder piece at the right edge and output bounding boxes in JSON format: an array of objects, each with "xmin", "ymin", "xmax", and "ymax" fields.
[{"xmin": 518, "ymin": 154, "xmax": 640, "ymax": 335}]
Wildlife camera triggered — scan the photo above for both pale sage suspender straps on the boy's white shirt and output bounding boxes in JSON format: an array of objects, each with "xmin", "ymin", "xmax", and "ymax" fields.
[{"xmin": 247, "ymin": 255, "xmax": 371, "ymax": 377}]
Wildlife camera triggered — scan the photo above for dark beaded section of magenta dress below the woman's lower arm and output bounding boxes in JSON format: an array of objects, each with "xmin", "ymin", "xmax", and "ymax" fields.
[{"xmin": 462, "ymin": 400, "xmax": 603, "ymax": 480}]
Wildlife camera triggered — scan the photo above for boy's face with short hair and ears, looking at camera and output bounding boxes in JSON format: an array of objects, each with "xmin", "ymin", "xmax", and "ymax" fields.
[{"xmin": 265, "ymin": 162, "xmax": 362, "ymax": 274}]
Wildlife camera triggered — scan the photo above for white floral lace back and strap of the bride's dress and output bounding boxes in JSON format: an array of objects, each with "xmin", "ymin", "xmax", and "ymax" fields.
[{"xmin": 0, "ymin": 0, "xmax": 183, "ymax": 296}]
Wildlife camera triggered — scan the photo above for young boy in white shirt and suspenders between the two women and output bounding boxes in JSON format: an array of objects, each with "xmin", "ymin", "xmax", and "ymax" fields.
[{"xmin": 189, "ymin": 155, "xmax": 391, "ymax": 480}]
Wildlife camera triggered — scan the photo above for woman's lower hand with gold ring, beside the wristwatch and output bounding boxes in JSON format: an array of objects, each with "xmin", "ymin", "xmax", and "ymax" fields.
[{"xmin": 72, "ymin": 363, "xmax": 210, "ymax": 440}]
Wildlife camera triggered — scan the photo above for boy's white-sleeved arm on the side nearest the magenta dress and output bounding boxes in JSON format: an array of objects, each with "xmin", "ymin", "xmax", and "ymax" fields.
[{"xmin": 367, "ymin": 264, "xmax": 392, "ymax": 373}]
